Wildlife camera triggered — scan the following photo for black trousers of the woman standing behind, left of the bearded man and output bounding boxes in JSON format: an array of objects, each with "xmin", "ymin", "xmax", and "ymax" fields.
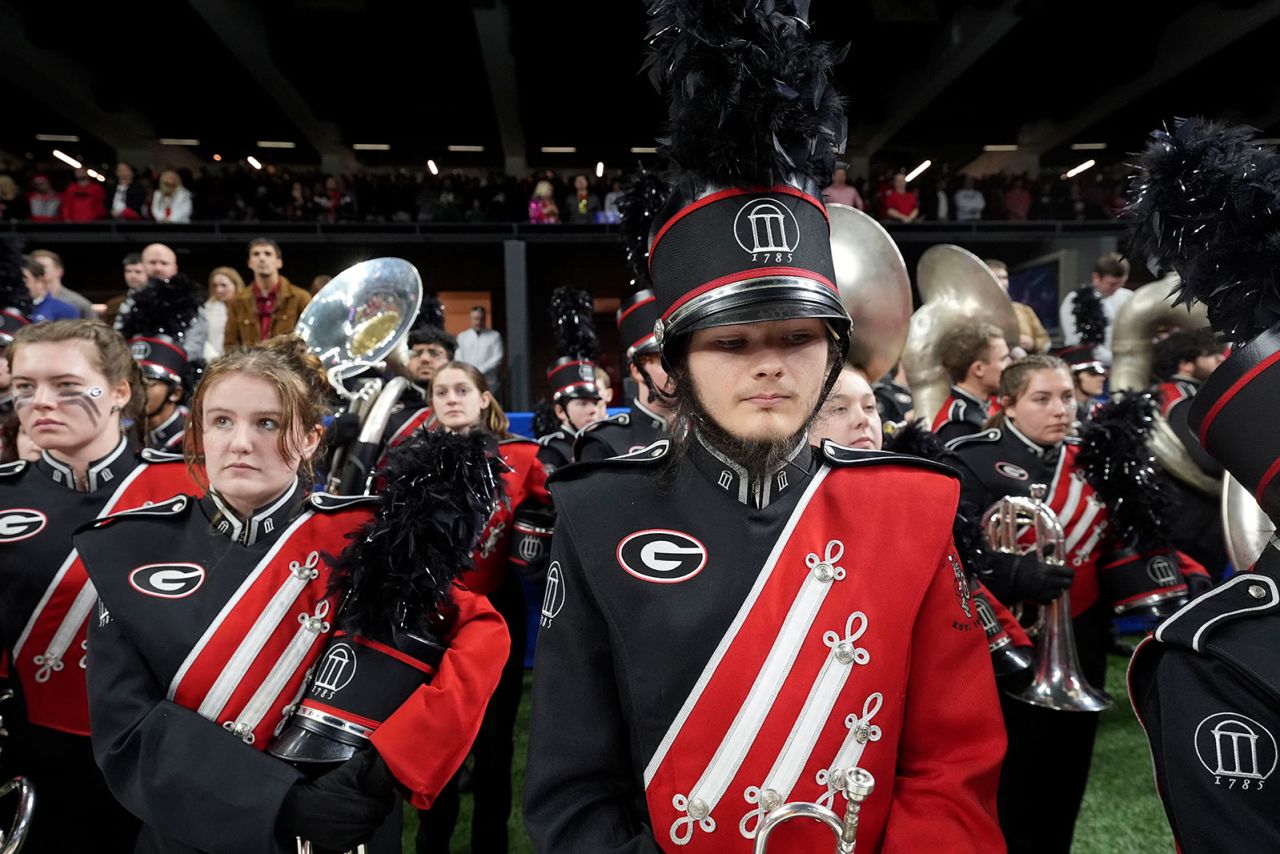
[{"xmin": 417, "ymin": 575, "xmax": 525, "ymax": 854}]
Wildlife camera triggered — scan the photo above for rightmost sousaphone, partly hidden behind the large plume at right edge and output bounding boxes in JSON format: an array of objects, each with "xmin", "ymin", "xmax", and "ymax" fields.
[{"xmin": 1111, "ymin": 273, "xmax": 1222, "ymax": 495}]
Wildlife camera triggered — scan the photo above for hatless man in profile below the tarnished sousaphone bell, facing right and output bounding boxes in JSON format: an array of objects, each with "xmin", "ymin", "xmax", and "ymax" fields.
[{"xmin": 933, "ymin": 321, "xmax": 1009, "ymax": 442}]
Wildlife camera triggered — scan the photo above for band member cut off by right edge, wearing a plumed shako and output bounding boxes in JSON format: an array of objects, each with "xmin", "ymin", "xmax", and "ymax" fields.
[{"xmin": 1129, "ymin": 119, "xmax": 1280, "ymax": 854}]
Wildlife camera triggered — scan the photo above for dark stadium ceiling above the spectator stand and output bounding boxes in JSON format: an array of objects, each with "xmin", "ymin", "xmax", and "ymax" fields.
[{"xmin": 0, "ymin": 0, "xmax": 1280, "ymax": 176}]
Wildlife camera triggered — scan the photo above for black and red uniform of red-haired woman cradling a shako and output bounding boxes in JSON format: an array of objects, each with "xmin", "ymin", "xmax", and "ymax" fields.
[{"xmin": 76, "ymin": 484, "xmax": 506, "ymax": 854}]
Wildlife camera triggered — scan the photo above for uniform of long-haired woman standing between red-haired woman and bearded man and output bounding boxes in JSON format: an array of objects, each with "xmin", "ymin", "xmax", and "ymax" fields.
[{"xmin": 417, "ymin": 438, "xmax": 554, "ymax": 854}]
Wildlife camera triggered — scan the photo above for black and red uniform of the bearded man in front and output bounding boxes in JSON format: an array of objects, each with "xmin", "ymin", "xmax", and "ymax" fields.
[{"xmin": 525, "ymin": 438, "xmax": 1004, "ymax": 854}]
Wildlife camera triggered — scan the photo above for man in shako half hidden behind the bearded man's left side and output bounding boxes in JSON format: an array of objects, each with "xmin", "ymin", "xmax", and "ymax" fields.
[{"xmin": 573, "ymin": 291, "xmax": 675, "ymax": 460}]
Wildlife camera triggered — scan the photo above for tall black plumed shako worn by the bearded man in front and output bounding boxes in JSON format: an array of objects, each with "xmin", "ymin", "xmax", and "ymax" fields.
[{"xmin": 648, "ymin": 0, "xmax": 850, "ymax": 356}]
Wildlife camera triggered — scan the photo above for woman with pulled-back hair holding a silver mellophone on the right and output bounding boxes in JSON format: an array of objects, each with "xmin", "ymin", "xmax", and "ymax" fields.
[{"xmin": 947, "ymin": 355, "xmax": 1208, "ymax": 854}]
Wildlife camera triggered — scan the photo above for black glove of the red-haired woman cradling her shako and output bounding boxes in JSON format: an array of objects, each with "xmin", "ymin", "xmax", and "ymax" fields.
[{"xmin": 275, "ymin": 746, "xmax": 396, "ymax": 851}]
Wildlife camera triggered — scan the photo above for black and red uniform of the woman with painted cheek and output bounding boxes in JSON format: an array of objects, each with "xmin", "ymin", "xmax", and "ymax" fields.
[{"xmin": 0, "ymin": 438, "xmax": 193, "ymax": 853}]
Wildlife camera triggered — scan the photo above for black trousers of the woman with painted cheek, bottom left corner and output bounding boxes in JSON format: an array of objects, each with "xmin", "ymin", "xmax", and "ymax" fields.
[{"xmin": 0, "ymin": 725, "xmax": 140, "ymax": 854}]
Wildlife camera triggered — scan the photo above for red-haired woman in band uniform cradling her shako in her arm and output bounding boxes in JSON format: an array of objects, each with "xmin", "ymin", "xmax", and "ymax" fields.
[{"xmin": 76, "ymin": 337, "xmax": 506, "ymax": 853}]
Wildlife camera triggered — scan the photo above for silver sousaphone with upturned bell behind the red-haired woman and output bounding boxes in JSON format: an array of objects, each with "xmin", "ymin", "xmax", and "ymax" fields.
[{"xmin": 296, "ymin": 257, "xmax": 422, "ymax": 495}]
